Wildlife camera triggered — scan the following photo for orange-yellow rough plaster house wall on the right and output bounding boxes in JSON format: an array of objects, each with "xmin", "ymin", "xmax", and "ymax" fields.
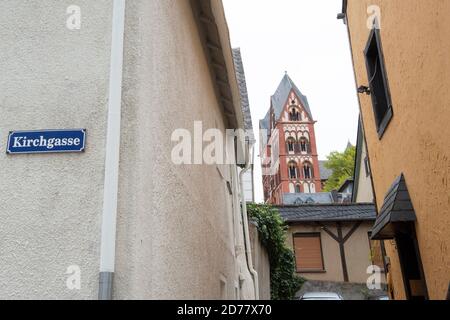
[{"xmin": 347, "ymin": 0, "xmax": 450, "ymax": 299}]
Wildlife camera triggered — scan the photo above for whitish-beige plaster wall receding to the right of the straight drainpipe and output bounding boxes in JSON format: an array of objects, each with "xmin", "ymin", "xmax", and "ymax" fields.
[{"xmin": 114, "ymin": 0, "xmax": 252, "ymax": 299}]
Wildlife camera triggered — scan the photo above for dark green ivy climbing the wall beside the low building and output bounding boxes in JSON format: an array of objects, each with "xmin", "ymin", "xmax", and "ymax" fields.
[{"xmin": 248, "ymin": 204, "xmax": 304, "ymax": 300}]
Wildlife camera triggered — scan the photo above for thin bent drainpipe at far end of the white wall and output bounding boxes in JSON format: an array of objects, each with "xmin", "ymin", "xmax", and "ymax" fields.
[{"xmin": 239, "ymin": 144, "xmax": 259, "ymax": 300}]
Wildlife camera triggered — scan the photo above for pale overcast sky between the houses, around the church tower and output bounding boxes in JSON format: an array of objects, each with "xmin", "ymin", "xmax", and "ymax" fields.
[{"xmin": 223, "ymin": 0, "xmax": 358, "ymax": 202}]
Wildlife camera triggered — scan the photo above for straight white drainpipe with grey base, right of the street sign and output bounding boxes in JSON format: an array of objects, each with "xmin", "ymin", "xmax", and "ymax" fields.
[{"xmin": 98, "ymin": 0, "xmax": 126, "ymax": 300}]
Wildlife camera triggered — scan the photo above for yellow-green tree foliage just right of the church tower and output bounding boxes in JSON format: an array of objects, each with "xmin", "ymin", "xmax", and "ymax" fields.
[{"xmin": 324, "ymin": 146, "xmax": 356, "ymax": 192}]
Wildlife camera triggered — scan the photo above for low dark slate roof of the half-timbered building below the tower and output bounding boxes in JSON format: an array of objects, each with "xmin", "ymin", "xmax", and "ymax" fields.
[{"xmin": 277, "ymin": 203, "xmax": 376, "ymax": 223}]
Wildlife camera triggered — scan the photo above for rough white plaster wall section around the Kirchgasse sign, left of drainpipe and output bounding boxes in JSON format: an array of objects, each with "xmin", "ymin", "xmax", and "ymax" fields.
[{"xmin": 0, "ymin": 0, "xmax": 112, "ymax": 299}]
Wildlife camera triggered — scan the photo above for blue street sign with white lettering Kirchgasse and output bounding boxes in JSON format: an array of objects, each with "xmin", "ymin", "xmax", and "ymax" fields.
[{"xmin": 6, "ymin": 129, "xmax": 86, "ymax": 154}]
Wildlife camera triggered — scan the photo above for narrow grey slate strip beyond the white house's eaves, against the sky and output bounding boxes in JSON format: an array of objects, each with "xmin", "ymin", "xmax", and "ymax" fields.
[{"xmin": 233, "ymin": 48, "xmax": 255, "ymax": 141}]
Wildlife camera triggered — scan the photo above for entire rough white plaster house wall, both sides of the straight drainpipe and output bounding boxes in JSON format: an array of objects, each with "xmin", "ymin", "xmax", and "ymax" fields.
[{"xmin": 0, "ymin": 0, "xmax": 254, "ymax": 299}]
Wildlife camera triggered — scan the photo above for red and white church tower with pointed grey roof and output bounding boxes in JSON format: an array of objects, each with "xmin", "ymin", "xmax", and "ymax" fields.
[{"xmin": 260, "ymin": 73, "xmax": 322, "ymax": 204}]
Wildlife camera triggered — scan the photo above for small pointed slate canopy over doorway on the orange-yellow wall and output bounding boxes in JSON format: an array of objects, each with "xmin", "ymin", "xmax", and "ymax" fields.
[{"xmin": 372, "ymin": 174, "xmax": 417, "ymax": 240}]
